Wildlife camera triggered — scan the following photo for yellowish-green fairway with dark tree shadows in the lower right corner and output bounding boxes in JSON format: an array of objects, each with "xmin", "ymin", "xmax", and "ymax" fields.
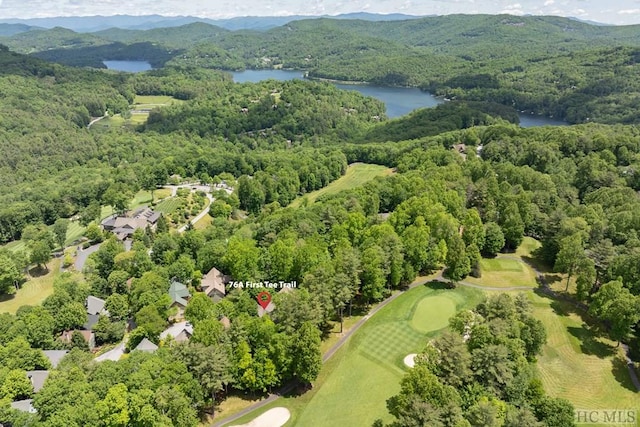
[{"xmin": 531, "ymin": 294, "xmax": 640, "ymax": 425}]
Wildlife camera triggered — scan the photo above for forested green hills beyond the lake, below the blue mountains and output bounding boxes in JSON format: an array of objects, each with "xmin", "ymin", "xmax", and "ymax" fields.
[{"xmin": 0, "ymin": 15, "xmax": 640, "ymax": 123}]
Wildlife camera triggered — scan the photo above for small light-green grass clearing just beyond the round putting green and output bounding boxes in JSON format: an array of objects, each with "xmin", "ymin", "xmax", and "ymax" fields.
[{"xmin": 464, "ymin": 255, "xmax": 537, "ymax": 288}]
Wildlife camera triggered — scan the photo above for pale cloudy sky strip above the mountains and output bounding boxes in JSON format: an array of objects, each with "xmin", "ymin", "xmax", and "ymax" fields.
[{"xmin": 0, "ymin": 0, "xmax": 640, "ymax": 25}]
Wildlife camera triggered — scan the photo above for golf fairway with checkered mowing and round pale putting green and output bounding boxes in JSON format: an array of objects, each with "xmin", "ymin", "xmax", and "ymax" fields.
[{"xmin": 222, "ymin": 285, "xmax": 483, "ymax": 427}]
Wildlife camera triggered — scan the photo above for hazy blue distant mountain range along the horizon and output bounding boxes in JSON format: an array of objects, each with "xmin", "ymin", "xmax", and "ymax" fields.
[{"xmin": 0, "ymin": 12, "xmax": 421, "ymax": 36}]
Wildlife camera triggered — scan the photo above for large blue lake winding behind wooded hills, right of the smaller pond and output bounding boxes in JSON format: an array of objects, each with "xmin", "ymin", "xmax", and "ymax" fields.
[{"xmin": 231, "ymin": 70, "xmax": 567, "ymax": 127}]
